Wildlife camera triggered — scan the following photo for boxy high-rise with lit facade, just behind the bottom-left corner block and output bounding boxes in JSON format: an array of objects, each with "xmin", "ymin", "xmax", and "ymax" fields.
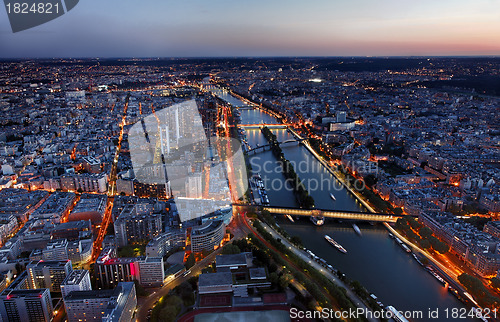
[{"xmin": 26, "ymin": 260, "xmax": 73, "ymax": 292}]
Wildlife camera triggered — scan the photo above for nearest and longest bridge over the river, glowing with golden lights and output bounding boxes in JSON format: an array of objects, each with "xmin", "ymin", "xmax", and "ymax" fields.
[{"xmin": 262, "ymin": 206, "xmax": 401, "ymax": 222}]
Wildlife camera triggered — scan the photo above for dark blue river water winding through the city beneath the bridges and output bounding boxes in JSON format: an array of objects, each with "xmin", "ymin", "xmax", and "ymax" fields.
[{"xmin": 212, "ymin": 88, "xmax": 472, "ymax": 321}]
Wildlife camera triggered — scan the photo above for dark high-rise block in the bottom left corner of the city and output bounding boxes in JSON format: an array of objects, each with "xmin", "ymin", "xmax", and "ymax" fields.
[{"xmin": 0, "ymin": 288, "xmax": 54, "ymax": 322}]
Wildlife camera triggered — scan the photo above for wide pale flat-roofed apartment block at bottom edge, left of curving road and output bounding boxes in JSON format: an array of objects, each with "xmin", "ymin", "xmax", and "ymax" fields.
[{"xmin": 64, "ymin": 282, "xmax": 137, "ymax": 322}]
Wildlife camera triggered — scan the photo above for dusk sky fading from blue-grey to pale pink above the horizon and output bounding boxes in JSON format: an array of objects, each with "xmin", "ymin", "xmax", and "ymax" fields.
[{"xmin": 0, "ymin": 0, "xmax": 500, "ymax": 58}]
